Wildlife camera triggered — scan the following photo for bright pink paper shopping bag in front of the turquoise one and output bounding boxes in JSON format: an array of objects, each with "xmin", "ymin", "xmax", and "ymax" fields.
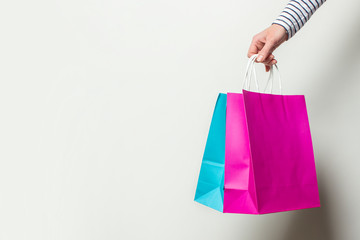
[{"xmin": 223, "ymin": 55, "xmax": 320, "ymax": 214}]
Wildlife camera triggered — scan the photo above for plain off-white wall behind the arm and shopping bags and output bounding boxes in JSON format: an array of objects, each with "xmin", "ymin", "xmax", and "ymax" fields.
[{"xmin": 0, "ymin": 0, "xmax": 360, "ymax": 240}]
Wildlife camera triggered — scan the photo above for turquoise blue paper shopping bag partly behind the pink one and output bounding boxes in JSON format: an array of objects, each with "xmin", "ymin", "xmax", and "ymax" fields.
[{"xmin": 195, "ymin": 93, "xmax": 226, "ymax": 212}]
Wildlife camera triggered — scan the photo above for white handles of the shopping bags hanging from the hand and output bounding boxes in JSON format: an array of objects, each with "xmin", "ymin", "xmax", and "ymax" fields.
[{"xmin": 243, "ymin": 54, "xmax": 282, "ymax": 94}]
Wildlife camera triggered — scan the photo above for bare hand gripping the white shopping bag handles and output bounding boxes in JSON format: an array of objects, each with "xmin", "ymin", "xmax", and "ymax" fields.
[{"xmin": 248, "ymin": 24, "xmax": 288, "ymax": 72}]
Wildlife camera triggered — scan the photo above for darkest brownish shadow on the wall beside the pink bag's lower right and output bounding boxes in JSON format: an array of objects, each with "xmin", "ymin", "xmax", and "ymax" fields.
[{"xmin": 280, "ymin": 171, "xmax": 335, "ymax": 240}]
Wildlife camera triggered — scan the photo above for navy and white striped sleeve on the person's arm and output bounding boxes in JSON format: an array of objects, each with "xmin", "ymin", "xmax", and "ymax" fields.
[{"xmin": 272, "ymin": 0, "xmax": 326, "ymax": 39}]
